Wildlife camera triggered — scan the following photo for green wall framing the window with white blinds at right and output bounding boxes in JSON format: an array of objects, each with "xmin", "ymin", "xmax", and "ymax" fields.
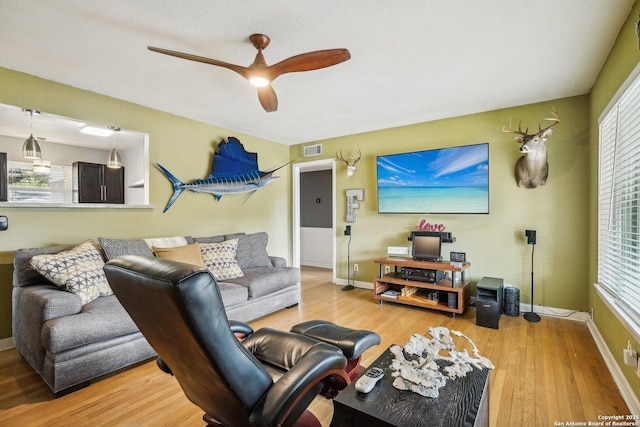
[{"xmin": 588, "ymin": 1, "xmax": 640, "ymax": 397}]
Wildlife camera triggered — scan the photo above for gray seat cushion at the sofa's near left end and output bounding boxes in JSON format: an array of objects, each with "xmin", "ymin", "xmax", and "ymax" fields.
[{"xmin": 41, "ymin": 295, "xmax": 138, "ymax": 353}]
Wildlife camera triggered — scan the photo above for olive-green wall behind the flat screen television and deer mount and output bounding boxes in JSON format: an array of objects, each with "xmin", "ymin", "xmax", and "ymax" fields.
[{"xmin": 291, "ymin": 95, "xmax": 589, "ymax": 310}]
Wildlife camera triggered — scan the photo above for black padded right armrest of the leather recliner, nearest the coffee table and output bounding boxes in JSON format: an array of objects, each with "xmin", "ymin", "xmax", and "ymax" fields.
[{"xmin": 251, "ymin": 349, "xmax": 350, "ymax": 425}]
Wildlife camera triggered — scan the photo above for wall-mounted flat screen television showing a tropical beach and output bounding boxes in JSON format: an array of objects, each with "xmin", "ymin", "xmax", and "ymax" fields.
[{"xmin": 376, "ymin": 143, "xmax": 489, "ymax": 214}]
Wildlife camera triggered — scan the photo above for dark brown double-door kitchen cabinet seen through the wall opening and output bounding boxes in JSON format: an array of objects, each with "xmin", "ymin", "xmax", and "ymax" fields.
[{"xmin": 73, "ymin": 162, "xmax": 124, "ymax": 204}]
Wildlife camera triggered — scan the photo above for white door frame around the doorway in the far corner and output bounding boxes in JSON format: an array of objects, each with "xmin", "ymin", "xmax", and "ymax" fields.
[{"xmin": 291, "ymin": 159, "xmax": 336, "ymax": 283}]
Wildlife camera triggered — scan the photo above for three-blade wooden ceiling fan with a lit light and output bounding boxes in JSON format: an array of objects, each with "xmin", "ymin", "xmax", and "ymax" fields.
[{"xmin": 148, "ymin": 34, "xmax": 351, "ymax": 112}]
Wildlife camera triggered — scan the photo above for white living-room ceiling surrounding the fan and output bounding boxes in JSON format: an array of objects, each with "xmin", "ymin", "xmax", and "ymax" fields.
[{"xmin": 0, "ymin": 0, "xmax": 633, "ymax": 145}]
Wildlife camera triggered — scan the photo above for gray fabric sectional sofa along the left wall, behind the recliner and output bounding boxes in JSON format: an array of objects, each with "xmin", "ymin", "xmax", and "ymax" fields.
[{"xmin": 12, "ymin": 233, "xmax": 300, "ymax": 396}]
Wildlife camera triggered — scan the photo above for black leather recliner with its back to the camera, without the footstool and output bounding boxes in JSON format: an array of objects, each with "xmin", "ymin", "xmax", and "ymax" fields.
[{"xmin": 104, "ymin": 255, "xmax": 349, "ymax": 426}]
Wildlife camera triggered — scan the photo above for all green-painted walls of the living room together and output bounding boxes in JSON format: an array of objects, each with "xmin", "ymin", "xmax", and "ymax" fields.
[{"xmin": 0, "ymin": 2, "xmax": 640, "ymax": 404}]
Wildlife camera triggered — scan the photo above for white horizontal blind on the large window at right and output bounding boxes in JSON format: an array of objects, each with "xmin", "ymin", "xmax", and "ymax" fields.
[{"xmin": 598, "ymin": 72, "xmax": 640, "ymax": 327}]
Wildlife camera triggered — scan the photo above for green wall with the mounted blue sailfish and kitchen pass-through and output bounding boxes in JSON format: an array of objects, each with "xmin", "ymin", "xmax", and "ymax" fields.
[{"xmin": 0, "ymin": 68, "xmax": 291, "ymax": 338}]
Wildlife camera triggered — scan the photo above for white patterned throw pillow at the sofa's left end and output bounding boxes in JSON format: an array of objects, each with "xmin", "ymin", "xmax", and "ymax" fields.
[{"xmin": 30, "ymin": 240, "xmax": 113, "ymax": 304}]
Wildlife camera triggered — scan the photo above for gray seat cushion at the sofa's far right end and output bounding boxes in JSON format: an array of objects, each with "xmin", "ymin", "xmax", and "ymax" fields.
[{"xmin": 227, "ymin": 267, "xmax": 300, "ymax": 298}]
